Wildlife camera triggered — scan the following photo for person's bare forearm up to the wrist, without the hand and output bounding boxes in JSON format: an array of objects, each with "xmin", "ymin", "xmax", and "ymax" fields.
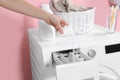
[{"xmin": 0, "ymin": 0, "xmax": 50, "ymax": 20}]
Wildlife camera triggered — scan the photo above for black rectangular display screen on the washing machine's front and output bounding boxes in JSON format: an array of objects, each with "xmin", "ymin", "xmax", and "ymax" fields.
[{"xmin": 105, "ymin": 44, "xmax": 120, "ymax": 54}]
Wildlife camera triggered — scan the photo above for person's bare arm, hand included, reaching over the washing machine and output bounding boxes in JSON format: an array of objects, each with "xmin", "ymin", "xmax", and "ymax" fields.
[{"xmin": 0, "ymin": 0, "xmax": 67, "ymax": 33}]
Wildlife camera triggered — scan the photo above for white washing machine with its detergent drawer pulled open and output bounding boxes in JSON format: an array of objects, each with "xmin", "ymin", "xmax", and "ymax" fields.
[{"xmin": 28, "ymin": 25, "xmax": 120, "ymax": 80}]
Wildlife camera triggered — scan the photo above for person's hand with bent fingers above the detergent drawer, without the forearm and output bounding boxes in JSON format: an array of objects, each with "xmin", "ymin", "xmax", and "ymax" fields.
[{"xmin": 45, "ymin": 14, "xmax": 68, "ymax": 34}]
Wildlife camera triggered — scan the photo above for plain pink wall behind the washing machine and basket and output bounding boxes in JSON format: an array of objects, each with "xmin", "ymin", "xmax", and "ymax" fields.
[{"xmin": 0, "ymin": 0, "xmax": 120, "ymax": 80}]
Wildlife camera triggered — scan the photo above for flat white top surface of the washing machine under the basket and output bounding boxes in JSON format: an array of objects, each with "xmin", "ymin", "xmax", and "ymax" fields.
[{"xmin": 29, "ymin": 25, "xmax": 120, "ymax": 51}]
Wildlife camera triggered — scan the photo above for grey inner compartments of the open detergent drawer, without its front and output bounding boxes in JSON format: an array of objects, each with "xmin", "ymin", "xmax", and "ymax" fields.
[{"xmin": 52, "ymin": 48, "xmax": 91, "ymax": 65}]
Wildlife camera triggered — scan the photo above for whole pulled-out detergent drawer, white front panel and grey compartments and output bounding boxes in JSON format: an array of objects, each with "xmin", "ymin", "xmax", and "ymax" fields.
[{"xmin": 52, "ymin": 49, "xmax": 99, "ymax": 80}]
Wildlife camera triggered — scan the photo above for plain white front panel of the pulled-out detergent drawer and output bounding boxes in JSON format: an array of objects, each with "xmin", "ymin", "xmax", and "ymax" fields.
[{"xmin": 55, "ymin": 60, "xmax": 99, "ymax": 80}]
